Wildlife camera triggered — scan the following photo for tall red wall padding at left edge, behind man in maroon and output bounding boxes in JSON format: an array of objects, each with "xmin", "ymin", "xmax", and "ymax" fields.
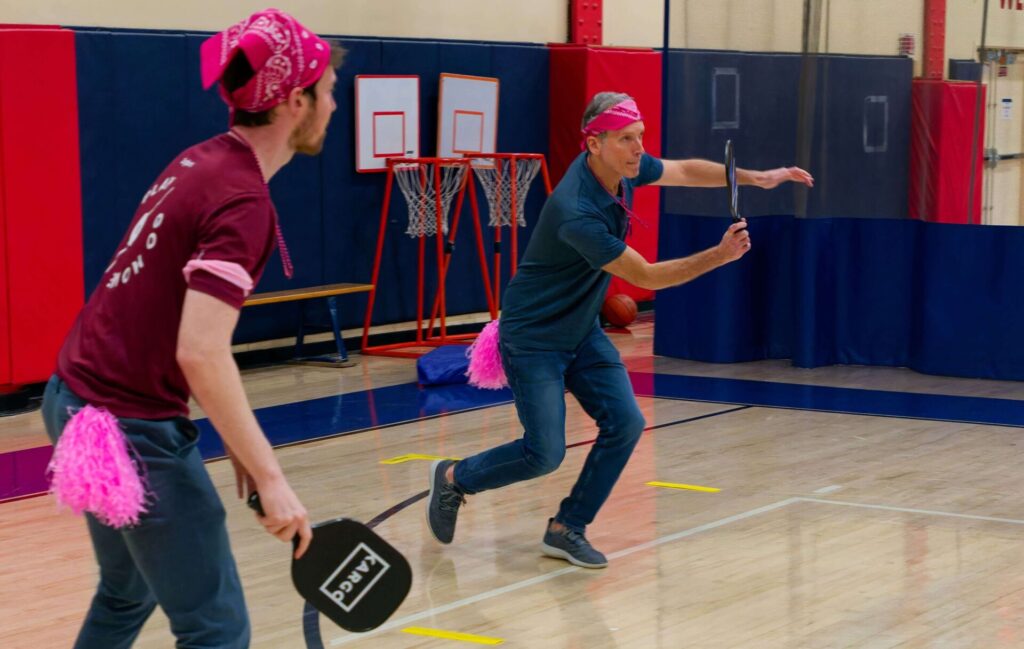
[{"xmin": 0, "ymin": 26, "xmax": 84, "ymax": 388}]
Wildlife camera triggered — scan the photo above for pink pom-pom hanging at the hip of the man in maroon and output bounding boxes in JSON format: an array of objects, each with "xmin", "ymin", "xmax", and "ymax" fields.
[{"xmin": 46, "ymin": 405, "xmax": 147, "ymax": 527}]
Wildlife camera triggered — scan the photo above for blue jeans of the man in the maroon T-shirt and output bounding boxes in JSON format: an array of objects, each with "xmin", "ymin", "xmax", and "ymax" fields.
[{"xmin": 43, "ymin": 376, "xmax": 250, "ymax": 649}]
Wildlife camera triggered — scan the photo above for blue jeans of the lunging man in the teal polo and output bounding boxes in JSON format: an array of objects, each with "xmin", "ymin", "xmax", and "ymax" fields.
[{"xmin": 455, "ymin": 326, "xmax": 645, "ymax": 532}]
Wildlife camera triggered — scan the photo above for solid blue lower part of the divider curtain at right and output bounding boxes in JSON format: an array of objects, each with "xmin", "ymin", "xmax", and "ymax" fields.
[{"xmin": 654, "ymin": 216, "xmax": 1024, "ymax": 380}]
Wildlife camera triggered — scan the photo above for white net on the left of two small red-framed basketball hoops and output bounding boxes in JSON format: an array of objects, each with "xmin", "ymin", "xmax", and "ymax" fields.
[{"xmin": 394, "ymin": 163, "xmax": 466, "ymax": 237}]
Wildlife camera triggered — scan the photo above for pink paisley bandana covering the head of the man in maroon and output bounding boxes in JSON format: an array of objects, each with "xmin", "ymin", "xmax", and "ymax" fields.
[{"xmin": 200, "ymin": 9, "xmax": 331, "ymax": 114}]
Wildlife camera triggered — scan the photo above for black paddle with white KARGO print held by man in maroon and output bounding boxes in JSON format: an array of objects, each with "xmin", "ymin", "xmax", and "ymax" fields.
[{"xmin": 248, "ymin": 492, "xmax": 413, "ymax": 633}]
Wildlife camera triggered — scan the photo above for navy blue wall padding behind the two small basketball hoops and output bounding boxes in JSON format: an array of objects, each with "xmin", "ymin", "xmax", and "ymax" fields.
[{"xmin": 76, "ymin": 29, "xmax": 548, "ymax": 342}]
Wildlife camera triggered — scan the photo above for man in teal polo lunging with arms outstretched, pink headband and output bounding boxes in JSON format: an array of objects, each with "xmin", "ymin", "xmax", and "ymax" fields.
[{"xmin": 427, "ymin": 92, "xmax": 813, "ymax": 568}]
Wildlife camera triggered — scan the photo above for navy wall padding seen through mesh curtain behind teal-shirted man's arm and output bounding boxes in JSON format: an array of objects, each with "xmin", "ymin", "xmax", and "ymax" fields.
[{"xmin": 665, "ymin": 50, "xmax": 913, "ymax": 218}]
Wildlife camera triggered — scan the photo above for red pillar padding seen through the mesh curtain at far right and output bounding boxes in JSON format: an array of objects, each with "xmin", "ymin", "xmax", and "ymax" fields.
[{"xmin": 909, "ymin": 79, "xmax": 985, "ymax": 223}]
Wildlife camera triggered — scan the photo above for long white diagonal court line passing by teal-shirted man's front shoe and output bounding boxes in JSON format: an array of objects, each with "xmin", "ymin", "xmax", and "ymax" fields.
[{"xmin": 331, "ymin": 497, "xmax": 798, "ymax": 647}]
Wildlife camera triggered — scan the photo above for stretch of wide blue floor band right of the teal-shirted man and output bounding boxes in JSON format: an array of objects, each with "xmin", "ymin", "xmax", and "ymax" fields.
[{"xmin": 630, "ymin": 373, "xmax": 1024, "ymax": 428}]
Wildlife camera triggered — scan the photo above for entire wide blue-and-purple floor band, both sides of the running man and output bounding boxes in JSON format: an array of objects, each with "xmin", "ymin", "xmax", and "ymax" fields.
[{"xmin": 8, "ymin": 373, "xmax": 1024, "ymax": 501}]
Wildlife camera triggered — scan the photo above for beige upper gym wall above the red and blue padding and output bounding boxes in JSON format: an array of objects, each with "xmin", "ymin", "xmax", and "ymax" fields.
[{"xmin": 0, "ymin": 0, "xmax": 999, "ymax": 73}]
